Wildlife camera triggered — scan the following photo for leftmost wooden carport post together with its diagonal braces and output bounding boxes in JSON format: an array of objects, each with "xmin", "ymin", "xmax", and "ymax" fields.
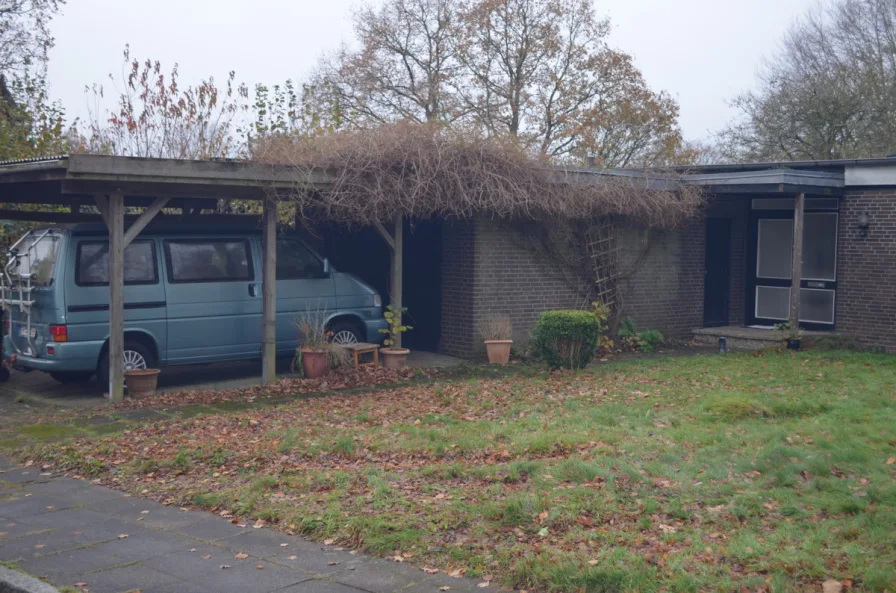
[{"xmin": 94, "ymin": 194, "xmax": 168, "ymax": 404}]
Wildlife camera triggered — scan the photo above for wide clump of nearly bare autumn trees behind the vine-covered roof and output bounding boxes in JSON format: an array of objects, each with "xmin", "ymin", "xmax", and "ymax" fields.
[{"xmin": 311, "ymin": 0, "xmax": 681, "ymax": 166}]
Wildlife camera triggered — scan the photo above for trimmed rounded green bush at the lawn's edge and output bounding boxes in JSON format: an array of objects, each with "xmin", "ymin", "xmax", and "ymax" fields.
[{"xmin": 532, "ymin": 311, "xmax": 600, "ymax": 369}]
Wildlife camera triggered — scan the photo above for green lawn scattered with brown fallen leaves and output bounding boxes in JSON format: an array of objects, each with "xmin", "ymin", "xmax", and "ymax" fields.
[{"xmin": 29, "ymin": 352, "xmax": 896, "ymax": 593}]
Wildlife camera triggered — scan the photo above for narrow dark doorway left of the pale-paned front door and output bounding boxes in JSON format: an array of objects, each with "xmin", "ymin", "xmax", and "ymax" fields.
[{"xmin": 703, "ymin": 218, "xmax": 731, "ymax": 327}]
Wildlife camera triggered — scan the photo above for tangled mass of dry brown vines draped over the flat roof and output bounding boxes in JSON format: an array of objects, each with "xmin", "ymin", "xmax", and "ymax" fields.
[{"xmin": 254, "ymin": 122, "xmax": 703, "ymax": 227}]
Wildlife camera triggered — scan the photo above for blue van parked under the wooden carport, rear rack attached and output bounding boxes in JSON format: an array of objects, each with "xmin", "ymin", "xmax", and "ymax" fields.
[{"xmin": 0, "ymin": 224, "xmax": 386, "ymax": 385}]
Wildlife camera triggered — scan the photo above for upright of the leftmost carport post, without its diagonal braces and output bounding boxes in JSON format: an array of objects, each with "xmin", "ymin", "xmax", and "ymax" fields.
[{"xmin": 107, "ymin": 195, "xmax": 124, "ymax": 403}]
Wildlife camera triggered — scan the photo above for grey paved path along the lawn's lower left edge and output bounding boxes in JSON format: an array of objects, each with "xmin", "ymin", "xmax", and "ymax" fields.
[{"xmin": 0, "ymin": 459, "xmax": 496, "ymax": 593}]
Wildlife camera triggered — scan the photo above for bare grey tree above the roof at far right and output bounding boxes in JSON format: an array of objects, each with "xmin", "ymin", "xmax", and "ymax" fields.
[{"xmin": 722, "ymin": 0, "xmax": 896, "ymax": 160}]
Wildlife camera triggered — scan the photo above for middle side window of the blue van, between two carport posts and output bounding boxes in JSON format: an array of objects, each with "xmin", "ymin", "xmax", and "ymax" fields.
[{"xmin": 165, "ymin": 239, "xmax": 253, "ymax": 282}]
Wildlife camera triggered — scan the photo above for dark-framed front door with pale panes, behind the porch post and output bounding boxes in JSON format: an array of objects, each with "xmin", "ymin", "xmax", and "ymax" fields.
[{"xmin": 747, "ymin": 198, "xmax": 839, "ymax": 330}]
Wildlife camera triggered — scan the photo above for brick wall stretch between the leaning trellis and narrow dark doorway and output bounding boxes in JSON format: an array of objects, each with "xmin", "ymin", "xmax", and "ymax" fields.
[{"xmin": 619, "ymin": 218, "xmax": 706, "ymax": 339}]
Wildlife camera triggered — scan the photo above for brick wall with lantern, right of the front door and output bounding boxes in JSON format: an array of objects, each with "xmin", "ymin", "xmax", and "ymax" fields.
[{"xmin": 835, "ymin": 189, "xmax": 896, "ymax": 352}]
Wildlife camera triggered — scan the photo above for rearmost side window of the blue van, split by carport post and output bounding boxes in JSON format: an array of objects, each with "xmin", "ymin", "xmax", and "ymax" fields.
[{"xmin": 75, "ymin": 241, "xmax": 159, "ymax": 286}]
